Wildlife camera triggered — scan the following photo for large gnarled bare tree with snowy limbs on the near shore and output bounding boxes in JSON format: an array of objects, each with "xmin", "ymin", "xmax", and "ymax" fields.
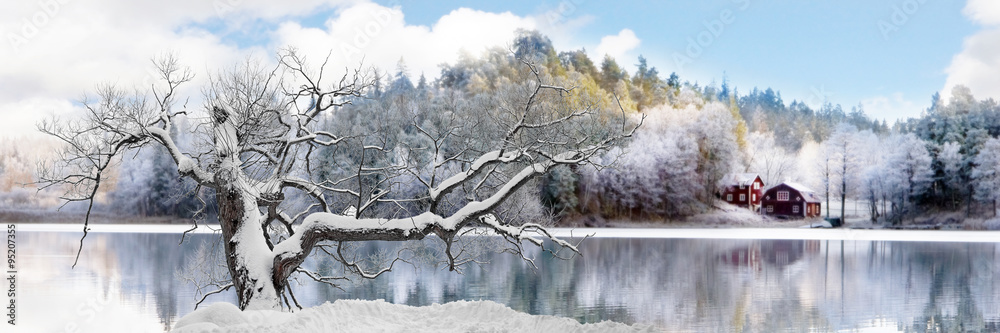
[{"xmin": 39, "ymin": 50, "xmax": 641, "ymax": 309}]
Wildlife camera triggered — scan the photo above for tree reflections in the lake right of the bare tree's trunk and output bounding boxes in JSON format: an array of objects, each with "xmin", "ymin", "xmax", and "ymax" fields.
[{"xmin": 197, "ymin": 238, "xmax": 1000, "ymax": 332}]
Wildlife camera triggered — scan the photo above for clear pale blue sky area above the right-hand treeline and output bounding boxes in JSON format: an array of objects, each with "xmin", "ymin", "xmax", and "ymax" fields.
[{"xmin": 370, "ymin": 0, "xmax": 977, "ymax": 121}]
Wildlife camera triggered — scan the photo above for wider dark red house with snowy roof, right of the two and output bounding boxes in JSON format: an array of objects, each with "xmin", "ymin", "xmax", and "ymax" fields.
[{"xmin": 760, "ymin": 182, "xmax": 820, "ymax": 218}]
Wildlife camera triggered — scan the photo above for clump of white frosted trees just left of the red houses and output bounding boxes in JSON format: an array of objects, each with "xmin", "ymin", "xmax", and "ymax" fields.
[{"xmin": 581, "ymin": 98, "xmax": 737, "ymax": 219}]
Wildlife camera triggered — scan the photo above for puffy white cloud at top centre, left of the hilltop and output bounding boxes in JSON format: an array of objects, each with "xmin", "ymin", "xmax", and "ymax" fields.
[{"xmin": 274, "ymin": 3, "xmax": 539, "ymax": 80}]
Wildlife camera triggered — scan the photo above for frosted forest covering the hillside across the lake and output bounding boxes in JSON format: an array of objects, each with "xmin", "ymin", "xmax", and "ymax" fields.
[{"xmin": 0, "ymin": 30, "xmax": 1000, "ymax": 227}]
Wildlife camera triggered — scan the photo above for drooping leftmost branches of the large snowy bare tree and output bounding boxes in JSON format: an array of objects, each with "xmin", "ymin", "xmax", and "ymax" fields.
[{"xmin": 36, "ymin": 55, "xmax": 212, "ymax": 266}]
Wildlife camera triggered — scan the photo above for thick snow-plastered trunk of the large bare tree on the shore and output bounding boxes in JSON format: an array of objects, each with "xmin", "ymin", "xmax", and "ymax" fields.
[{"xmin": 215, "ymin": 170, "xmax": 284, "ymax": 310}]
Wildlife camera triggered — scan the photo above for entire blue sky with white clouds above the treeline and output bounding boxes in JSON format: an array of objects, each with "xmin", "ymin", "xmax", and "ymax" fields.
[{"xmin": 0, "ymin": 0, "xmax": 1000, "ymax": 135}]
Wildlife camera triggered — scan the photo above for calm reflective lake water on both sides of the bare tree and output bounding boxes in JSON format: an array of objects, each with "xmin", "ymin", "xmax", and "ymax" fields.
[{"xmin": 11, "ymin": 225, "xmax": 1000, "ymax": 332}]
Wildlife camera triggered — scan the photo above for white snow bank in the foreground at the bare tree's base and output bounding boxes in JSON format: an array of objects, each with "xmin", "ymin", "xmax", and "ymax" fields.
[{"xmin": 172, "ymin": 300, "xmax": 653, "ymax": 333}]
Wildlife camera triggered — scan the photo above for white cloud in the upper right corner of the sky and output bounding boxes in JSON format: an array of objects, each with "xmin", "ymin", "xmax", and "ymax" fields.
[{"xmin": 941, "ymin": 0, "xmax": 1000, "ymax": 100}]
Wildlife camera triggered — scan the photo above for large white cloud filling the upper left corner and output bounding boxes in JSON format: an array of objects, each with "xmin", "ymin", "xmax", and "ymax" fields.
[{"xmin": 0, "ymin": 0, "xmax": 354, "ymax": 135}]
